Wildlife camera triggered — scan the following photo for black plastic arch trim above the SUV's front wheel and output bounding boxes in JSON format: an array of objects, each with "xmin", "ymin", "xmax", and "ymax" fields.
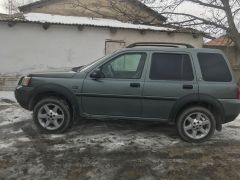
[{"xmin": 29, "ymin": 84, "xmax": 80, "ymax": 119}]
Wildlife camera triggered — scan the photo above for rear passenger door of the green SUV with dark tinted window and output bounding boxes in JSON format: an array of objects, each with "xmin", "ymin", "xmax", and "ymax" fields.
[{"xmin": 143, "ymin": 51, "xmax": 198, "ymax": 120}]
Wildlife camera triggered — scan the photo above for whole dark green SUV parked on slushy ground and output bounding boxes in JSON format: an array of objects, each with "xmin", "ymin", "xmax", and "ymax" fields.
[{"xmin": 15, "ymin": 43, "xmax": 240, "ymax": 143}]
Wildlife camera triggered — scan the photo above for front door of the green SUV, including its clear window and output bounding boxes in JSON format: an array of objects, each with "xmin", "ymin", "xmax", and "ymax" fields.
[{"xmin": 82, "ymin": 52, "xmax": 147, "ymax": 117}]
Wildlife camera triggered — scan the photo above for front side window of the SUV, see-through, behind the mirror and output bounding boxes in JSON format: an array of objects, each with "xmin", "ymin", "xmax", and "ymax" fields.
[{"xmin": 101, "ymin": 53, "xmax": 147, "ymax": 79}]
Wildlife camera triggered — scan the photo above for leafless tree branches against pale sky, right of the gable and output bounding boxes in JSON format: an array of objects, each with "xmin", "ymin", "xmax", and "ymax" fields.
[{"xmin": 142, "ymin": 0, "xmax": 240, "ymax": 50}]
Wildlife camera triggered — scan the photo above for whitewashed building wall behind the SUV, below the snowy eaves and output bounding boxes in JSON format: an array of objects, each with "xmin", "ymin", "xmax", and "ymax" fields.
[{"xmin": 0, "ymin": 23, "xmax": 203, "ymax": 74}]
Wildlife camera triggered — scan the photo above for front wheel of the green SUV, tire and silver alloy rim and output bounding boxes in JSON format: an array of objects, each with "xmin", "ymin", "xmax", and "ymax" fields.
[{"xmin": 33, "ymin": 97, "xmax": 72, "ymax": 133}]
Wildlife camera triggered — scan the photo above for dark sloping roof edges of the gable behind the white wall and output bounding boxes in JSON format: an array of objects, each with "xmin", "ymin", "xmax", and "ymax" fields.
[{"xmin": 19, "ymin": 0, "xmax": 167, "ymax": 22}]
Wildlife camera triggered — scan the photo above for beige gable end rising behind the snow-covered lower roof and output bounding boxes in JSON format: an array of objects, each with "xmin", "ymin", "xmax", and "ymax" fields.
[{"xmin": 19, "ymin": 0, "xmax": 166, "ymax": 24}]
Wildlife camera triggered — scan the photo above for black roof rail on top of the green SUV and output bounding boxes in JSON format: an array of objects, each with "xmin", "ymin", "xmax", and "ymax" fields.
[{"xmin": 127, "ymin": 42, "xmax": 194, "ymax": 48}]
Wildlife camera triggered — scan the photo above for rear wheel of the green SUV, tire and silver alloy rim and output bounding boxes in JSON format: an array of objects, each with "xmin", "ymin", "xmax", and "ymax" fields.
[{"xmin": 177, "ymin": 107, "xmax": 216, "ymax": 143}]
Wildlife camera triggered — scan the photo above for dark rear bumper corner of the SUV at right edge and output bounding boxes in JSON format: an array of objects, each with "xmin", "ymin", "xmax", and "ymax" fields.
[{"xmin": 220, "ymin": 99, "xmax": 240, "ymax": 124}]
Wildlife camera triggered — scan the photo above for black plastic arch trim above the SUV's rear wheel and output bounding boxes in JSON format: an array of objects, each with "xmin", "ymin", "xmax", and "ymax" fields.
[{"xmin": 169, "ymin": 94, "xmax": 225, "ymax": 130}]
